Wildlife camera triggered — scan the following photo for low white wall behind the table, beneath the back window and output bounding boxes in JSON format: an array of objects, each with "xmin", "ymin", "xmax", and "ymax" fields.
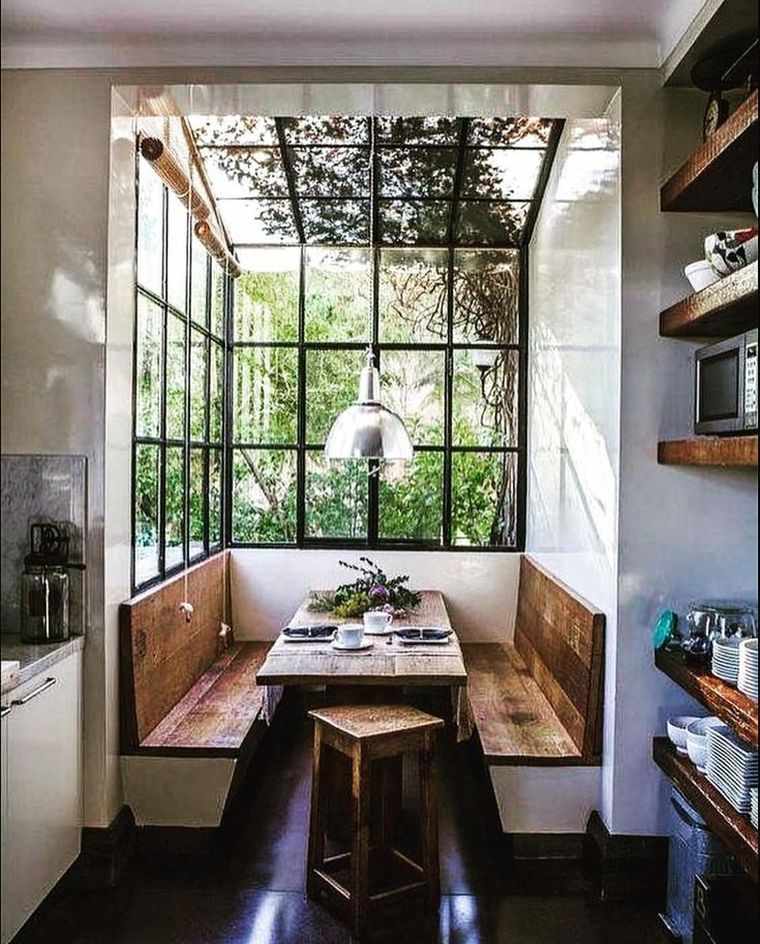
[{"xmin": 230, "ymin": 548, "xmax": 520, "ymax": 642}]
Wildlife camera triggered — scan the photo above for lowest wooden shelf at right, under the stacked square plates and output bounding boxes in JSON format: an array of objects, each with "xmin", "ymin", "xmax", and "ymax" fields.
[{"xmin": 652, "ymin": 738, "xmax": 758, "ymax": 882}]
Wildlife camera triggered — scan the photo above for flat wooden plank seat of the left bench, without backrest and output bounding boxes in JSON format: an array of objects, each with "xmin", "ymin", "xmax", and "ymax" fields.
[{"xmin": 136, "ymin": 642, "xmax": 270, "ymax": 757}]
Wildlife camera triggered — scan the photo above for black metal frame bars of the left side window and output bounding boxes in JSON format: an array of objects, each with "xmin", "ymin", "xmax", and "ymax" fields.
[{"xmin": 130, "ymin": 155, "xmax": 232, "ymax": 594}]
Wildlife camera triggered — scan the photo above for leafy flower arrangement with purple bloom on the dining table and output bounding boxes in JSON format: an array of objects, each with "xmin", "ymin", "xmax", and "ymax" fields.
[{"xmin": 309, "ymin": 557, "xmax": 422, "ymax": 619}]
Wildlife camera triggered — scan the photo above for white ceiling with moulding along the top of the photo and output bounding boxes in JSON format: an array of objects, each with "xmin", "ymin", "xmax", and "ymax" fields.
[{"xmin": 2, "ymin": 0, "xmax": 715, "ymax": 67}]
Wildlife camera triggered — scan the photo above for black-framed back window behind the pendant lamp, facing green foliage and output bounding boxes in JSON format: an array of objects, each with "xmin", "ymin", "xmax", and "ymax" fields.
[{"xmin": 227, "ymin": 246, "xmax": 527, "ymax": 550}]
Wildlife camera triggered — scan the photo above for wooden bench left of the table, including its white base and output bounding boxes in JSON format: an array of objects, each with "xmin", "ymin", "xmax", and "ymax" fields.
[{"xmin": 119, "ymin": 552, "xmax": 270, "ymax": 826}]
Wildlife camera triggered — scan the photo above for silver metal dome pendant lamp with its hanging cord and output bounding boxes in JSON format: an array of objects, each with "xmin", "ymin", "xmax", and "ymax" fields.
[{"xmin": 325, "ymin": 119, "xmax": 414, "ymax": 462}]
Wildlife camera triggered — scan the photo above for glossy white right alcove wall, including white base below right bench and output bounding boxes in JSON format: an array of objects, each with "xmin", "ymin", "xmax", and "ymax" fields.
[{"xmin": 524, "ymin": 93, "xmax": 621, "ymax": 832}]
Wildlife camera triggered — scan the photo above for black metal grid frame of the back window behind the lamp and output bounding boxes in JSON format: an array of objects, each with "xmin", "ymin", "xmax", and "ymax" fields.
[{"xmin": 224, "ymin": 243, "xmax": 528, "ymax": 553}]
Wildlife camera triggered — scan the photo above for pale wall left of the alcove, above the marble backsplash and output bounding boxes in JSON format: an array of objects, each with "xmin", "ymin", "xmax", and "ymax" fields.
[{"xmin": 2, "ymin": 72, "xmax": 118, "ymax": 823}]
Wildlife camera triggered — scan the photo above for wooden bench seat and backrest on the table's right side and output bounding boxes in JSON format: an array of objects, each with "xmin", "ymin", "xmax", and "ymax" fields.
[{"xmin": 462, "ymin": 557, "xmax": 605, "ymax": 766}]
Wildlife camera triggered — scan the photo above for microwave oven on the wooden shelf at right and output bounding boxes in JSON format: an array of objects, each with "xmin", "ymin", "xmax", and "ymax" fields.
[{"xmin": 694, "ymin": 328, "xmax": 757, "ymax": 436}]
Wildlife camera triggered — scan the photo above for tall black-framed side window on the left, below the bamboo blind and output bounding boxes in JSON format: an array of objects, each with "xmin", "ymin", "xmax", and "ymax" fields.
[{"xmin": 132, "ymin": 157, "xmax": 229, "ymax": 589}]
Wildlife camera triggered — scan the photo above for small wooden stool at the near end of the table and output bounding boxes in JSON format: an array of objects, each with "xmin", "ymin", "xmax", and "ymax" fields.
[{"xmin": 306, "ymin": 705, "xmax": 443, "ymax": 937}]
